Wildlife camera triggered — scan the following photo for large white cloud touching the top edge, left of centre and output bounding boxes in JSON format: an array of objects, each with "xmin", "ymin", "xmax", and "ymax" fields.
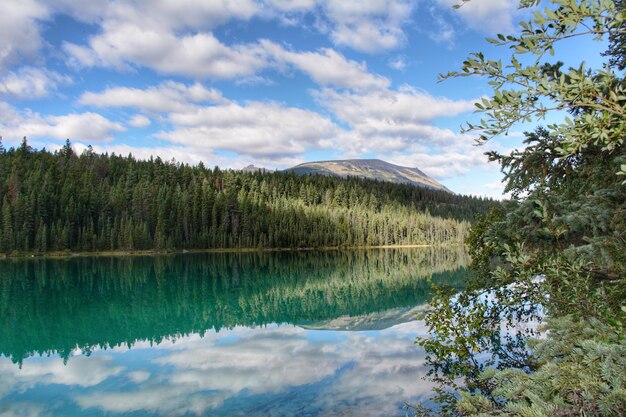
[{"xmin": 60, "ymin": 0, "xmax": 264, "ymax": 79}]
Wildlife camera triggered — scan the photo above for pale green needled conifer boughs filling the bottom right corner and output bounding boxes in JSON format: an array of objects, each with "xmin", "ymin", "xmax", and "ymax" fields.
[{"xmin": 457, "ymin": 316, "xmax": 626, "ymax": 417}]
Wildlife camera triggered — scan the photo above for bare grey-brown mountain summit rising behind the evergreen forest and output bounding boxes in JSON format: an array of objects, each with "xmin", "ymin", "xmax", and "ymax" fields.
[{"xmin": 286, "ymin": 159, "xmax": 450, "ymax": 191}]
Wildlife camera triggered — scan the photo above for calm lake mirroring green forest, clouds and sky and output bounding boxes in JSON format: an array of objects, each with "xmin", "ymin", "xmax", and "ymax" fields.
[{"xmin": 0, "ymin": 248, "xmax": 468, "ymax": 417}]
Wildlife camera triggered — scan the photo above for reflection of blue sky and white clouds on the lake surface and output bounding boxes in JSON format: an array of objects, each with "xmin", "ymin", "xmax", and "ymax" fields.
[{"xmin": 0, "ymin": 321, "xmax": 432, "ymax": 416}]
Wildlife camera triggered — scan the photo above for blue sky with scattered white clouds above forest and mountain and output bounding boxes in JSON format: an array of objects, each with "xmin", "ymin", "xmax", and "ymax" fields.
[{"xmin": 0, "ymin": 0, "xmax": 602, "ymax": 198}]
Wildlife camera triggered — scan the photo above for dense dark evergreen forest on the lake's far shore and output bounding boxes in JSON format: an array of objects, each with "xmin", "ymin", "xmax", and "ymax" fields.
[{"xmin": 0, "ymin": 138, "xmax": 493, "ymax": 253}]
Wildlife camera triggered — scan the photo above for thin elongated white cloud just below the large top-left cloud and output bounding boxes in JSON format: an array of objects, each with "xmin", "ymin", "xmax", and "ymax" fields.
[{"xmin": 78, "ymin": 81, "xmax": 226, "ymax": 112}]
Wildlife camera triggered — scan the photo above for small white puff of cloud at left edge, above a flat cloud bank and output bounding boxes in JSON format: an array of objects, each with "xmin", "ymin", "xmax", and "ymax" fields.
[{"xmin": 0, "ymin": 67, "xmax": 72, "ymax": 100}]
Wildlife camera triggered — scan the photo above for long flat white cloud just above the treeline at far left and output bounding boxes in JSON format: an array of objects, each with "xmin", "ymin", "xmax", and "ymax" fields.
[{"xmin": 0, "ymin": 103, "xmax": 125, "ymax": 142}]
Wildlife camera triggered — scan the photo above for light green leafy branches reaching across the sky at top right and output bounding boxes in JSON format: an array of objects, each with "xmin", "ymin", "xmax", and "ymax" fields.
[{"xmin": 442, "ymin": 0, "xmax": 626, "ymax": 156}]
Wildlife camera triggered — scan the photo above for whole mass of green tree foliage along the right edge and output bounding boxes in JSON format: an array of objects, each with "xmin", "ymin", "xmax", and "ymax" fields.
[{"xmin": 418, "ymin": 0, "xmax": 626, "ymax": 416}]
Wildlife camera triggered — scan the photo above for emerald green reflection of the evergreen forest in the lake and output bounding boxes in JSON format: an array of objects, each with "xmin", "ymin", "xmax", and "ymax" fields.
[{"xmin": 0, "ymin": 248, "xmax": 467, "ymax": 361}]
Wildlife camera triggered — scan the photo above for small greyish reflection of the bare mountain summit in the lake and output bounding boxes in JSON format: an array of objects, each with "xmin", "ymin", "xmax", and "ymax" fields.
[{"xmin": 298, "ymin": 304, "xmax": 425, "ymax": 331}]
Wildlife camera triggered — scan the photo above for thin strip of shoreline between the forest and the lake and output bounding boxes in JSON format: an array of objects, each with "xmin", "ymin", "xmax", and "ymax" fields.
[{"xmin": 0, "ymin": 243, "xmax": 464, "ymax": 261}]
